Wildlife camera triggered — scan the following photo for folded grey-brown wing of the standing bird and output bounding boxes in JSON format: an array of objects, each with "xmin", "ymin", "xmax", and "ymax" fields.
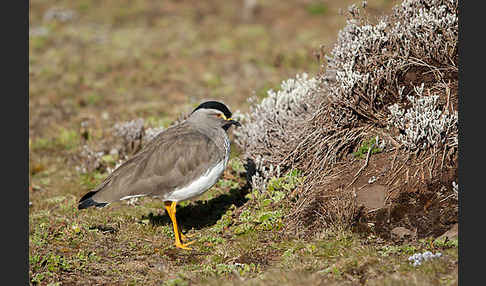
[{"xmin": 93, "ymin": 129, "xmax": 224, "ymax": 203}]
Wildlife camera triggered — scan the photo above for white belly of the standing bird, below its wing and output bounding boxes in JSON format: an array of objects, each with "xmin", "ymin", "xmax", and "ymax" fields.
[{"xmin": 163, "ymin": 160, "xmax": 226, "ymax": 202}]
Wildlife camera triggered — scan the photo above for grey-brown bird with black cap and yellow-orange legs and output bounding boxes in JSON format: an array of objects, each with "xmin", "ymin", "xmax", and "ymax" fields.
[{"xmin": 78, "ymin": 101, "xmax": 241, "ymax": 250}]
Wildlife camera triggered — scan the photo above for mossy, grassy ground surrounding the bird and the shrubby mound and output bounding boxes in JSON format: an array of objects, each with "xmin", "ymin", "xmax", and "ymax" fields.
[{"xmin": 29, "ymin": 0, "xmax": 458, "ymax": 285}]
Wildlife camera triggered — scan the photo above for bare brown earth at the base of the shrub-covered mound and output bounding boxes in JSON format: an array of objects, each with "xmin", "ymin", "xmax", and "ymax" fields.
[{"xmin": 282, "ymin": 144, "xmax": 458, "ymax": 239}]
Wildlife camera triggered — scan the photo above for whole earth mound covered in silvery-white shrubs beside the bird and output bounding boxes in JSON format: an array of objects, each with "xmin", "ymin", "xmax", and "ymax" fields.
[{"xmin": 236, "ymin": 0, "xmax": 458, "ymax": 239}]
